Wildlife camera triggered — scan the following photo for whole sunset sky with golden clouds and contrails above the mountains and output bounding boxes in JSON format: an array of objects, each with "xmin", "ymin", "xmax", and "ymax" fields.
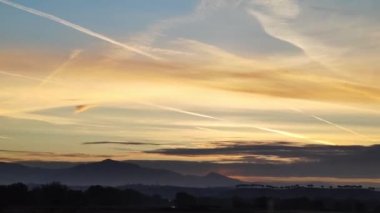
[{"xmin": 0, "ymin": 0, "xmax": 380, "ymax": 184}]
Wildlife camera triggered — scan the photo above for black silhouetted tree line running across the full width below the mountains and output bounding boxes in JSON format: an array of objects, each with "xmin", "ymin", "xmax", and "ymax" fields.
[{"xmin": 0, "ymin": 183, "xmax": 380, "ymax": 213}]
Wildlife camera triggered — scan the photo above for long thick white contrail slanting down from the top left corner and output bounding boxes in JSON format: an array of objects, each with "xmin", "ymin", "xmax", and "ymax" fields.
[{"xmin": 0, "ymin": 0, "xmax": 160, "ymax": 60}]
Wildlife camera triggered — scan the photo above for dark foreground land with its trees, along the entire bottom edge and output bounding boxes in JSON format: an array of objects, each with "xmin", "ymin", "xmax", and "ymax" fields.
[{"xmin": 0, "ymin": 183, "xmax": 380, "ymax": 213}]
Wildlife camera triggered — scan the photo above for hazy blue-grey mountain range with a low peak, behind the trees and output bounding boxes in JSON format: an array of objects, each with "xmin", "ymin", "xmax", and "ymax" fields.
[{"xmin": 0, "ymin": 160, "xmax": 241, "ymax": 187}]
